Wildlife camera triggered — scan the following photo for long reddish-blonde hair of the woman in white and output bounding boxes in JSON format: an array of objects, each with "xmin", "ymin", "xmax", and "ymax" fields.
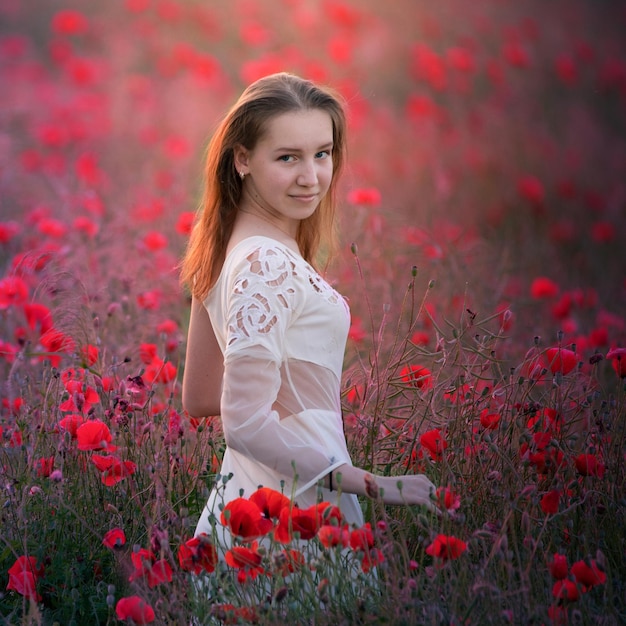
[{"xmin": 180, "ymin": 72, "xmax": 346, "ymax": 299}]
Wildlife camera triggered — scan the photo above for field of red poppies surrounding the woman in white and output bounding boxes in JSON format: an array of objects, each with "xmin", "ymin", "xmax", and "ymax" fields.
[{"xmin": 0, "ymin": 0, "xmax": 626, "ymax": 626}]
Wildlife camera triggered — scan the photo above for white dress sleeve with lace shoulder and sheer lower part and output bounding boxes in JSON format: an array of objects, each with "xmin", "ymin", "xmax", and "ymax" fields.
[{"xmin": 221, "ymin": 248, "xmax": 345, "ymax": 492}]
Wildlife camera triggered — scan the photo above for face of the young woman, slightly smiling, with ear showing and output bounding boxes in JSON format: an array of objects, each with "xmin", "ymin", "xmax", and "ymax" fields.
[{"xmin": 235, "ymin": 109, "xmax": 333, "ymax": 236}]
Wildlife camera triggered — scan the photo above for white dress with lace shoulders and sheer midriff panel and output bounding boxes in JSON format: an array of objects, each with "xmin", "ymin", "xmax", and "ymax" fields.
[{"xmin": 196, "ymin": 236, "xmax": 363, "ymax": 544}]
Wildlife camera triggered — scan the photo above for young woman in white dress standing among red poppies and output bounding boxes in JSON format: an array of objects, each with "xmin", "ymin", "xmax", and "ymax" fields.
[{"xmin": 181, "ymin": 73, "xmax": 434, "ymax": 534}]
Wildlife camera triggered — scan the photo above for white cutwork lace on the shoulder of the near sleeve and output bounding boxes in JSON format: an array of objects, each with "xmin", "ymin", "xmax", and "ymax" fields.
[{"xmin": 228, "ymin": 248, "xmax": 296, "ymax": 345}]
